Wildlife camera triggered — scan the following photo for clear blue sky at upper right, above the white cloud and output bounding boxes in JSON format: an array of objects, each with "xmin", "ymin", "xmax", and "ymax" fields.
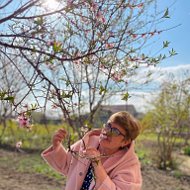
[{"xmin": 160, "ymin": 0, "xmax": 190, "ymax": 66}]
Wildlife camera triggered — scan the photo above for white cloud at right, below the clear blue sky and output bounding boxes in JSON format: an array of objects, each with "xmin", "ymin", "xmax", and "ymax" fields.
[{"xmin": 111, "ymin": 64, "xmax": 190, "ymax": 112}]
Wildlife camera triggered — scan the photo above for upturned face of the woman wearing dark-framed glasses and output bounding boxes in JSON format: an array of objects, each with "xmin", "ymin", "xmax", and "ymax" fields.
[{"xmin": 100, "ymin": 121, "xmax": 126, "ymax": 151}]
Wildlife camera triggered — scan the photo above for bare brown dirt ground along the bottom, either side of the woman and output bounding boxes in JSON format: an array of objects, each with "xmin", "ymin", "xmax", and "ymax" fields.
[{"xmin": 0, "ymin": 150, "xmax": 190, "ymax": 190}]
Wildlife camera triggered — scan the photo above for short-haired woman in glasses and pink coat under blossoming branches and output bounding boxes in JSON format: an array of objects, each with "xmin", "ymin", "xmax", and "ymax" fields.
[{"xmin": 42, "ymin": 112, "xmax": 142, "ymax": 190}]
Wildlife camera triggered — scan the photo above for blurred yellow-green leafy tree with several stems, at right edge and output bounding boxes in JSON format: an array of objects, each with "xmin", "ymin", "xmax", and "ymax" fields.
[{"xmin": 143, "ymin": 74, "xmax": 190, "ymax": 169}]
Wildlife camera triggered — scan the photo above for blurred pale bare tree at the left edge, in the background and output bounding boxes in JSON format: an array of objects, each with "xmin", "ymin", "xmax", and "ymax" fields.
[{"xmin": 0, "ymin": 54, "xmax": 28, "ymax": 139}]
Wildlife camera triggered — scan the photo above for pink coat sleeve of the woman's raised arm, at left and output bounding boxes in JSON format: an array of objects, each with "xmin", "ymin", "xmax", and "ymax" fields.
[{"xmin": 41, "ymin": 141, "xmax": 80, "ymax": 176}]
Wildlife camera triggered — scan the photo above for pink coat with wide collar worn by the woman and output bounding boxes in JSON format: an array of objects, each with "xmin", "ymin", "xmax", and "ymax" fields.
[{"xmin": 42, "ymin": 131, "xmax": 142, "ymax": 190}]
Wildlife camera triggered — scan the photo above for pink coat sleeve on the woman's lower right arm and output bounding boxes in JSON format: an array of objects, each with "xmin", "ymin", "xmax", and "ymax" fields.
[{"xmin": 95, "ymin": 164, "xmax": 142, "ymax": 190}]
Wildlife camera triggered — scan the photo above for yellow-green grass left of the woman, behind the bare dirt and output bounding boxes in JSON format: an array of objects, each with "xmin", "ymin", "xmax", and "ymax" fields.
[{"xmin": 0, "ymin": 122, "xmax": 71, "ymax": 181}]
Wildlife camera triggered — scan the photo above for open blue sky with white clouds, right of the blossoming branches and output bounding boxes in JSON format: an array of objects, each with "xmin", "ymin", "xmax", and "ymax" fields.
[{"xmin": 117, "ymin": 0, "xmax": 190, "ymax": 112}]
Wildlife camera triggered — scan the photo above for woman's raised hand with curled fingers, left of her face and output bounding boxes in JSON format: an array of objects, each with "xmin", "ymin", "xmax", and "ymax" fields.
[{"xmin": 52, "ymin": 129, "xmax": 67, "ymax": 149}]
